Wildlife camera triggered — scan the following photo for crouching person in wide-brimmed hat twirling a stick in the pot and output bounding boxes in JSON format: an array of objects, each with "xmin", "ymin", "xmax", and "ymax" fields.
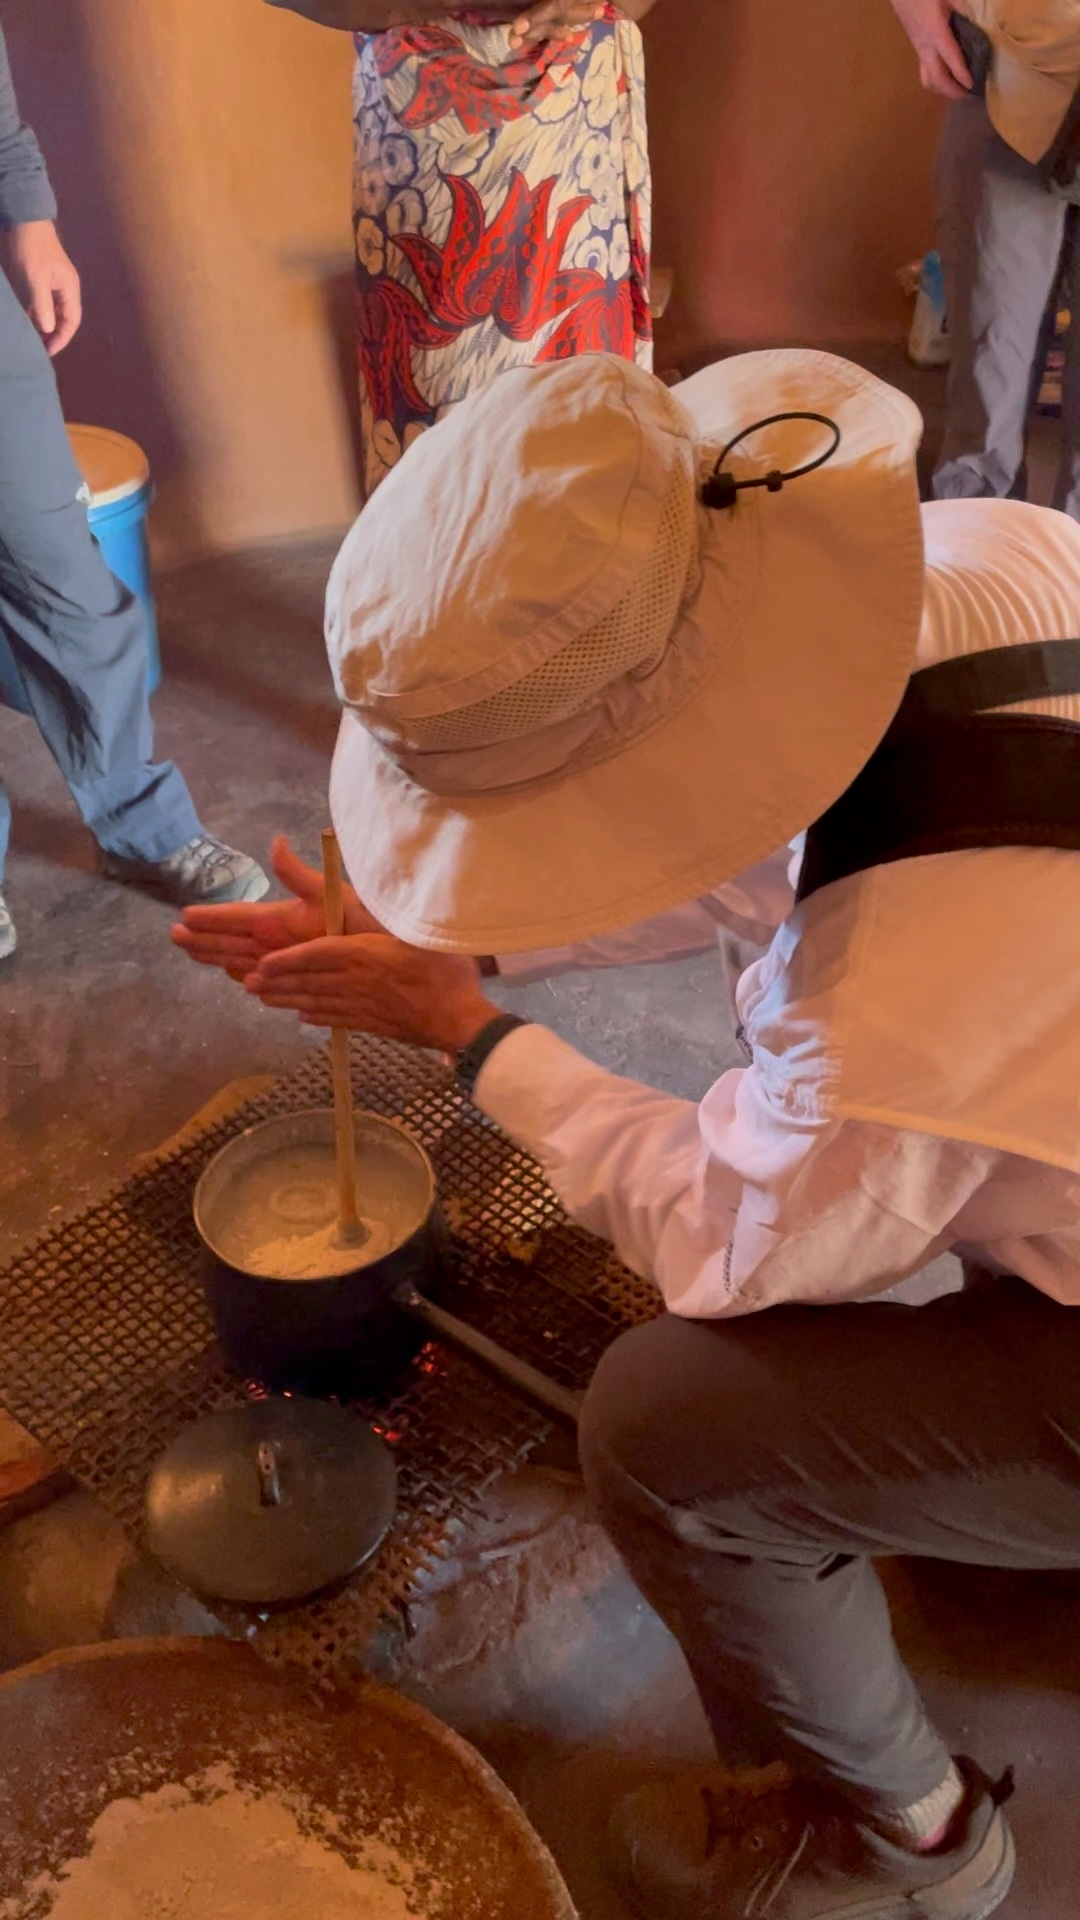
[{"xmin": 177, "ymin": 351, "xmax": 1080, "ymax": 1920}]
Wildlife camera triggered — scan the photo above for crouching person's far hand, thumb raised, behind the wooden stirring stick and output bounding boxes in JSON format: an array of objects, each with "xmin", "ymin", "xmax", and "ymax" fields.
[{"xmin": 173, "ymin": 835, "xmax": 382, "ymax": 981}]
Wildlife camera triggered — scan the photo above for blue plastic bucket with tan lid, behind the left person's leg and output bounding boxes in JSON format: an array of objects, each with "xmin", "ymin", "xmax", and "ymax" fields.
[{"xmin": 0, "ymin": 426, "xmax": 161, "ymax": 714}]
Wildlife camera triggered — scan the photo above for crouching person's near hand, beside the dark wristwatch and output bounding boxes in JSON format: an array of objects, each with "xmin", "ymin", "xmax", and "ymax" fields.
[{"xmin": 244, "ymin": 933, "xmax": 498, "ymax": 1052}]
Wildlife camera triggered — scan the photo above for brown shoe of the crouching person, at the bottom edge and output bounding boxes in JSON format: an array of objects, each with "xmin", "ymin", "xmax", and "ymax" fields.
[{"xmin": 611, "ymin": 1761, "xmax": 1015, "ymax": 1920}]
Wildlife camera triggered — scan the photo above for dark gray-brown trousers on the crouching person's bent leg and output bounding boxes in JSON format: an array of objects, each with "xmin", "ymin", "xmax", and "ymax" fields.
[{"xmin": 580, "ymin": 1279, "xmax": 1080, "ymax": 1811}]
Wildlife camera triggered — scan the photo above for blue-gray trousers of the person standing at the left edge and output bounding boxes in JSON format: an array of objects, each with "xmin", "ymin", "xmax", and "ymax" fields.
[{"xmin": 0, "ymin": 273, "xmax": 198, "ymax": 879}]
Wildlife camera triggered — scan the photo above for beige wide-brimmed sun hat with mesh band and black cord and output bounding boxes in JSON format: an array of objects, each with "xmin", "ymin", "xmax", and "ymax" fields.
[{"xmin": 327, "ymin": 351, "xmax": 922, "ymax": 954}]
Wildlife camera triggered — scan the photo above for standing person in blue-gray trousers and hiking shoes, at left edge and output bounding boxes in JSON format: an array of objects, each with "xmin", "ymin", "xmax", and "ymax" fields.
[{"xmin": 0, "ymin": 29, "xmax": 269, "ymax": 960}]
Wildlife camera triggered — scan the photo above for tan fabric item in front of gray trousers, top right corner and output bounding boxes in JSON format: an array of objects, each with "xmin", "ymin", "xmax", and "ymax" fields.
[{"xmin": 959, "ymin": 0, "xmax": 1080, "ymax": 165}]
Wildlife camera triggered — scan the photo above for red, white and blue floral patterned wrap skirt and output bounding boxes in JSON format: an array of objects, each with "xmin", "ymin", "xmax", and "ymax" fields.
[{"xmin": 356, "ymin": 8, "xmax": 651, "ymax": 490}]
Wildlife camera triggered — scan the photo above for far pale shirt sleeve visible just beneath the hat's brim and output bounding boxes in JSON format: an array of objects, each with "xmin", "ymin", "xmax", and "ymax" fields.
[{"xmin": 498, "ymin": 847, "xmax": 794, "ymax": 987}]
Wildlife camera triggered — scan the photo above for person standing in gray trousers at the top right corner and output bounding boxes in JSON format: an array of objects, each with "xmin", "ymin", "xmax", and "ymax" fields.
[{"xmin": 894, "ymin": 0, "xmax": 1080, "ymax": 520}]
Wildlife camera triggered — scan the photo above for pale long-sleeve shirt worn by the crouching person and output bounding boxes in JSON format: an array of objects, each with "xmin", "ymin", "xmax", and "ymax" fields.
[{"xmin": 477, "ymin": 501, "xmax": 1080, "ymax": 1319}]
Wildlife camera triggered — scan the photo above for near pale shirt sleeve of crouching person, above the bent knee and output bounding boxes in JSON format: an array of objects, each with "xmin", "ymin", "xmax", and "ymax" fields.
[{"xmin": 477, "ymin": 1025, "xmax": 995, "ymax": 1319}]
